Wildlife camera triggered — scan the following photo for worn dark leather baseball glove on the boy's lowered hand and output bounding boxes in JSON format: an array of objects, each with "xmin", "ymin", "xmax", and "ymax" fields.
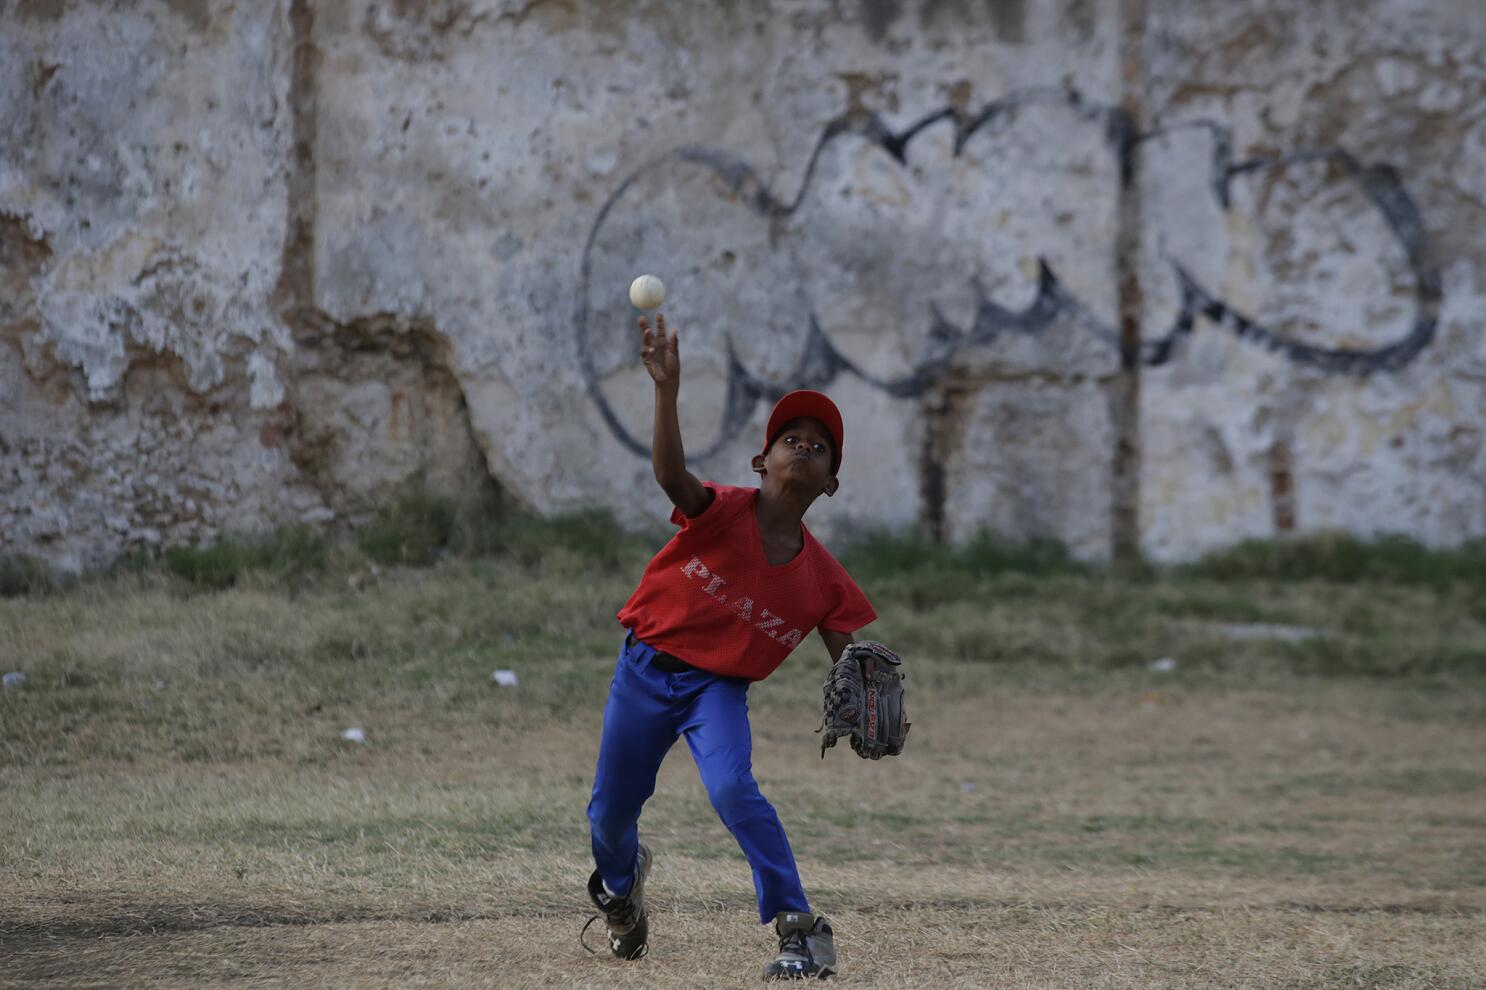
[{"xmin": 816, "ymin": 641, "xmax": 908, "ymax": 760}]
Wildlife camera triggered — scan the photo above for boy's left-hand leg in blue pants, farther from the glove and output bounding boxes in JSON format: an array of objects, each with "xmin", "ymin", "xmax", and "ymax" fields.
[{"xmin": 588, "ymin": 642, "xmax": 676, "ymax": 898}]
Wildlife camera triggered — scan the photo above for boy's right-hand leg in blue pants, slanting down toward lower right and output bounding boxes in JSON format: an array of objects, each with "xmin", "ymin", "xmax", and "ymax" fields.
[{"xmin": 681, "ymin": 678, "xmax": 810, "ymax": 925}]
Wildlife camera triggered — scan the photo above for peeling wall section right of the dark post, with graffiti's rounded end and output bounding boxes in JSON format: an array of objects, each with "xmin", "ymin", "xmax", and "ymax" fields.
[{"xmin": 1141, "ymin": 0, "xmax": 1486, "ymax": 557}]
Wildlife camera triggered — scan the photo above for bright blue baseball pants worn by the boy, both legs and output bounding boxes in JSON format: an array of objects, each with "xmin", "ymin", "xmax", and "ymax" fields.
[{"xmin": 588, "ymin": 627, "xmax": 810, "ymax": 925}]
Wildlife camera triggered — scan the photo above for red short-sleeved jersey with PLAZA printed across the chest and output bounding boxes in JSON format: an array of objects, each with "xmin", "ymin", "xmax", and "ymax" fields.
[{"xmin": 620, "ymin": 482, "xmax": 877, "ymax": 681}]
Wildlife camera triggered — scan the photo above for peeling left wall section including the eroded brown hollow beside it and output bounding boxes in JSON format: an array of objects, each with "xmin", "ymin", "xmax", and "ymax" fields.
[{"xmin": 0, "ymin": 1, "xmax": 484, "ymax": 568}]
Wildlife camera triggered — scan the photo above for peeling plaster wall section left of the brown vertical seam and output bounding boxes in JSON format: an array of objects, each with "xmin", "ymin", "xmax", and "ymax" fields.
[{"xmin": 0, "ymin": 3, "xmax": 315, "ymax": 568}]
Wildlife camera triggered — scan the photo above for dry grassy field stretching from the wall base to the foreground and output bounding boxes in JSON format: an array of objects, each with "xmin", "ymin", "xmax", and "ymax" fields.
[{"xmin": 0, "ymin": 520, "xmax": 1486, "ymax": 989}]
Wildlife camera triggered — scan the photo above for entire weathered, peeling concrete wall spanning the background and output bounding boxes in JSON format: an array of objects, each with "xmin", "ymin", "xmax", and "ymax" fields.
[{"xmin": 0, "ymin": 0, "xmax": 1486, "ymax": 565}]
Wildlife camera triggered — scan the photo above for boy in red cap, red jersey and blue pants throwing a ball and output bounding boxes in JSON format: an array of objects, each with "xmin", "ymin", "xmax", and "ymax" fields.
[{"xmin": 588, "ymin": 315, "xmax": 877, "ymax": 980}]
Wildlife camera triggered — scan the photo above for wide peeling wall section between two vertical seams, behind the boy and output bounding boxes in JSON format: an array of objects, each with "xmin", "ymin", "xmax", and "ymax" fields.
[{"xmin": 317, "ymin": 3, "xmax": 1116, "ymax": 554}]
